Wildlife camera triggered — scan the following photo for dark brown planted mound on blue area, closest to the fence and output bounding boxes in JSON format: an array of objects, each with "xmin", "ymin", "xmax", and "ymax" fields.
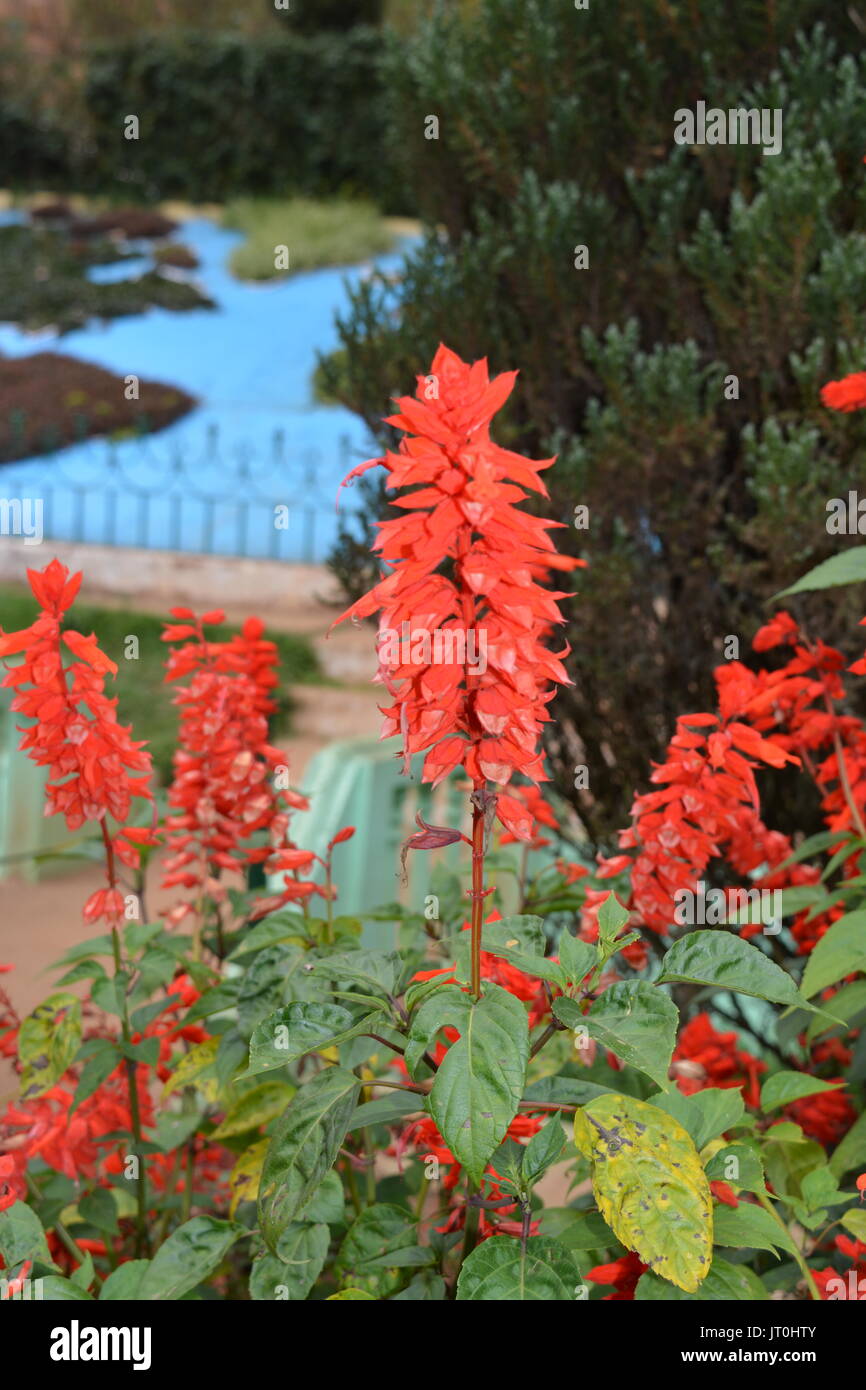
[{"xmin": 0, "ymin": 352, "xmax": 195, "ymax": 463}]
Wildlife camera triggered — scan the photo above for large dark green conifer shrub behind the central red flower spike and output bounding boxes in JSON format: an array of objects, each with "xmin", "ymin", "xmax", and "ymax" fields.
[{"xmin": 320, "ymin": 0, "xmax": 866, "ymax": 840}]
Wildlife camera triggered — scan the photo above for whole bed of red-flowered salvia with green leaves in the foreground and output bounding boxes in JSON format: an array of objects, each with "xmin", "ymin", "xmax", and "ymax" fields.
[{"xmin": 0, "ymin": 348, "xmax": 866, "ymax": 1301}]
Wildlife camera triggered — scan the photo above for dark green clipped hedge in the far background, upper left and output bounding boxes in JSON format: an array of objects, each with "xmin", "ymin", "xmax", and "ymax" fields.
[{"xmin": 81, "ymin": 25, "xmax": 388, "ymax": 202}]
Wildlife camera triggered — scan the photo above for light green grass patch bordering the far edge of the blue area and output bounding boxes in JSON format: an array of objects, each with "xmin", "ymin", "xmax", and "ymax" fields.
[{"xmin": 222, "ymin": 197, "xmax": 396, "ymax": 279}]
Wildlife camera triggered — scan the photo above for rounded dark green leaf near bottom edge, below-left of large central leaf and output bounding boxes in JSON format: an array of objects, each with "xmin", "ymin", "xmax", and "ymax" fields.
[{"xmin": 334, "ymin": 1202, "xmax": 435, "ymax": 1298}]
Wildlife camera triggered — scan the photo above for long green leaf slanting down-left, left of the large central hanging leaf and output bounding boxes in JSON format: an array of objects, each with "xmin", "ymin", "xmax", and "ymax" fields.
[{"xmin": 259, "ymin": 1066, "xmax": 360, "ymax": 1254}]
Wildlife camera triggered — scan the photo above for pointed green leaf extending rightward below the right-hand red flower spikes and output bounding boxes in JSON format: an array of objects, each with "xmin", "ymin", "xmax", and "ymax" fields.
[{"xmin": 657, "ymin": 931, "xmax": 803, "ymax": 1005}]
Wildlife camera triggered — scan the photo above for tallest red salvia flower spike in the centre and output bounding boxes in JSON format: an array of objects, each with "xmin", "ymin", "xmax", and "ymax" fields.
[{"xmin": 338, "ymin": 348, "xmax": 581, "ymax": 822}]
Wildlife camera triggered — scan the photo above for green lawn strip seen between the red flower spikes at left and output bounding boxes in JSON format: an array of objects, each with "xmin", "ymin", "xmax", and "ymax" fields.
[{"xmin": 0, "ymin": 584, "xmax": 322, "ymax": 785}]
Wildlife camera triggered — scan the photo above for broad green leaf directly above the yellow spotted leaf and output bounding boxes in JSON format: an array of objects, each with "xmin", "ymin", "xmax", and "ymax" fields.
[{"xmin": 553, "ymin": 980, "xmax": 680, "ymax": 1090}]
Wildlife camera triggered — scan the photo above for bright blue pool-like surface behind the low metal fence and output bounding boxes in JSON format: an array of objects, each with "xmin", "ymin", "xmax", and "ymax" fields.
[{"xmin": 0, "ymin": 215, "xmax": 406, "ymax": 560}]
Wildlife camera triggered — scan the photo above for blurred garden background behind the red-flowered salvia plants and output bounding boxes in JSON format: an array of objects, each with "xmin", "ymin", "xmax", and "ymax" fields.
[{"xmin": 0, "ymin": 0, "xmax": 866, "ymax": 998}]
